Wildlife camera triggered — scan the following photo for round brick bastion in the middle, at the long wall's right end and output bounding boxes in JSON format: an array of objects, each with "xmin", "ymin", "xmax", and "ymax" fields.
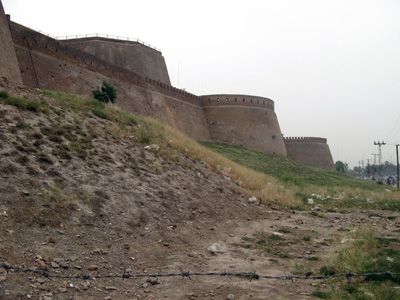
[{"xmin": 201, "ymin": 94, "xmax": 286, "ymax": 156}]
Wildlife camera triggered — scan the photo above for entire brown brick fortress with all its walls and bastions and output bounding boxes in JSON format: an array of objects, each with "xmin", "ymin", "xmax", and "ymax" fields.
[{"xmin": 0, "ymin": 0, "xmax": 334, "ymax": 170}]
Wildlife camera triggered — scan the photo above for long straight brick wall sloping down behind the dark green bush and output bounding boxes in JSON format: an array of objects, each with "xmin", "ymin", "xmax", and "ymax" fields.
[{"xmin": 10, "ymin": 21, "xmax": 209, "ymax": 140}]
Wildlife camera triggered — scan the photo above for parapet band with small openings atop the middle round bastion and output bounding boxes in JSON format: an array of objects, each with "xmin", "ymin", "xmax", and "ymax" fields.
[{"xmin": 201, "ymin": 94, "xmax": 274, "ymax": 111}]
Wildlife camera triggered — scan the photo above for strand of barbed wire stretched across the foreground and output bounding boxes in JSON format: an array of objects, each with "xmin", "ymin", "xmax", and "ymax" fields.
[{"xmin": 0, "ymin": 262, "xmax": 400, "ymax": 284}]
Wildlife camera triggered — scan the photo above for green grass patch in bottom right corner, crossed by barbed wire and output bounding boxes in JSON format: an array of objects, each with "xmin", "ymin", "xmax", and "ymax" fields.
[{"xmin": 314, "ymin": 227, "xmax": 400, "ymax": 299}]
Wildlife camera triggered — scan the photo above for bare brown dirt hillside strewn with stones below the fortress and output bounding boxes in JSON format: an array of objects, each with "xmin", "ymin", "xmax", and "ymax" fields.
[{"xmin": 0, "ymin": 82, "xmax": 400, "ymax": 300}]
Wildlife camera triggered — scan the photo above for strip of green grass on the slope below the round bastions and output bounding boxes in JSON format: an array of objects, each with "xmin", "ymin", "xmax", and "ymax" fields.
[{"xmin": 200, "ymin": 142, "xmax": 382, "ymax": 190}]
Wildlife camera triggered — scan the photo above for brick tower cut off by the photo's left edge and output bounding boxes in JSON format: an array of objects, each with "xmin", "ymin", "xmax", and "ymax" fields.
[{"xmin": 0, "ymin": 0, "xmax": 22, "ymax": 84}]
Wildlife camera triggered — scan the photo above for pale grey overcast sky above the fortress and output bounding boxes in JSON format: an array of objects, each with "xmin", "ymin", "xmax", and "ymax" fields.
[{"xmin": 2, "ymin": 0, "xmax": 400, "ymax": 166}]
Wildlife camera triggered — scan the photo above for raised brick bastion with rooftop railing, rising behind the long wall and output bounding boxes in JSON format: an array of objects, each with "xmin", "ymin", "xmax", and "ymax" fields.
[{"xmin": 60, "ymin": 37, "xmax": 171, "ymax": 85}]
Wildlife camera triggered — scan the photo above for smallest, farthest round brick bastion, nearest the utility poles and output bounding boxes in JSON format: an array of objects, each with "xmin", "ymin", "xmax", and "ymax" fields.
[{"xmin": 284, "ymin": 137, "xmax": 335, "ymax": 171}]
